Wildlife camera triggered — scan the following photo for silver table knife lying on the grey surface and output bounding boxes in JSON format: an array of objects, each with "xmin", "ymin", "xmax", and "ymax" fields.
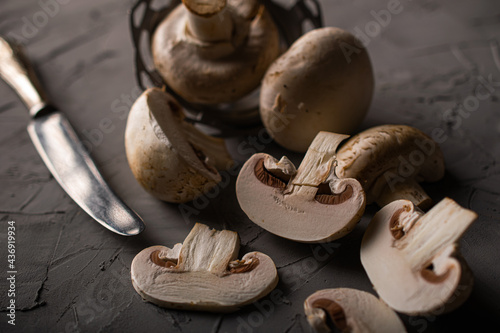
[{"xmin": 0, "ymin": 37, "xmax": 144, "ymax": 236}]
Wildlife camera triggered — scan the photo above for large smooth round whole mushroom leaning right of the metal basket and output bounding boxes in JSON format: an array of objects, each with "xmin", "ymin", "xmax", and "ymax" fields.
[{"xmin": 260, "ymin": 27, "xmax": 374, "ymax": 152}]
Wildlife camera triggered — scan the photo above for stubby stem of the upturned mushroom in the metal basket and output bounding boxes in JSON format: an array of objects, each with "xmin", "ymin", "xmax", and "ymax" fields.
[{"xmin": 182, "ymin": 0, "xmax": 234, "ymax": 43}]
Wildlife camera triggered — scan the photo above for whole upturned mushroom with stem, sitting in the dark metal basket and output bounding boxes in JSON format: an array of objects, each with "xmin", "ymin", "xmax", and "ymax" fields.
[{"xmin": 152, "ymin": 0, "xmax": 280, "ymax": 104}]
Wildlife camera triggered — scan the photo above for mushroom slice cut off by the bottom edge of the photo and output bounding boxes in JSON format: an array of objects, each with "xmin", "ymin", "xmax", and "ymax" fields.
[{"xmin": 304, "ymin": 288, "xmax": 406, "ymax": 333}]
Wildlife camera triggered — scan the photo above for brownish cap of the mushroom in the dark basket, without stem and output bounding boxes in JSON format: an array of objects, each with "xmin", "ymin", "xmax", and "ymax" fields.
[{"xmin": 152, "ymin": 1, "xmax": 280, "ymax": 104}]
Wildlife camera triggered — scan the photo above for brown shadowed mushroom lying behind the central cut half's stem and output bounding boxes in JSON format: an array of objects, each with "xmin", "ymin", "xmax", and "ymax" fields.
[{"xmin": 336, "ymin": 125, "xmax": 445, "ymax": 209}]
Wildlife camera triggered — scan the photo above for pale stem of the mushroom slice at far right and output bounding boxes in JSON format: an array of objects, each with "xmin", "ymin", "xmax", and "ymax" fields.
[{"xmin": 395, "ymin": 198, "xmax": 477, "ymax": 270}]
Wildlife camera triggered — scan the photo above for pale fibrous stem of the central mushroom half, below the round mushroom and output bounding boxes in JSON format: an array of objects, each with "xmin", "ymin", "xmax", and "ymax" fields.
[{"xmin": 288, "ymin": 132, "xmax": 349, "ymax": 191}]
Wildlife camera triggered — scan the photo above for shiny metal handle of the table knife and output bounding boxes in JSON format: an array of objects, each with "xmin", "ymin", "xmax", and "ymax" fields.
[{"xmin": 0, "ymin": 37, "xmax": 49, "ymax": 117}]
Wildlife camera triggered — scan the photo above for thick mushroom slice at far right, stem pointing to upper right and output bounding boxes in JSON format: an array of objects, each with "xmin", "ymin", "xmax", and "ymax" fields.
[{"xmin": 361, "ymin": 198, "xmax": 477, "ymax": 315}]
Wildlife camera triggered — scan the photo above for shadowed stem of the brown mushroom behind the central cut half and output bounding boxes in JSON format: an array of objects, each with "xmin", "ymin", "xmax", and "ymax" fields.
[{"xmin": 376, "ymin": 179, "xmax": 432, "ymax": 209}]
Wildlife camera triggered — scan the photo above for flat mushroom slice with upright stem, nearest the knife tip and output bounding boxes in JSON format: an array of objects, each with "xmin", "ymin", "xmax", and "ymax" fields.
[{"xmin": 131, "ymin": 223, "xmax": 278, "ymax": 312}]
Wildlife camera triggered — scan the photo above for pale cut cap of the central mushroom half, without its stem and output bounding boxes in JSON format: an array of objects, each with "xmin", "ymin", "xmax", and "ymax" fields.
[{"xmin": 236, "ymin": 153, "xmax": 365, "ymax": 243}]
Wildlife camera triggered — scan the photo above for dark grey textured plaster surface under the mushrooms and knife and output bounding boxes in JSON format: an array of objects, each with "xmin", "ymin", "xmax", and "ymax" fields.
[{"xmin": 0, "ymin": 0, "xmax": 500, "ymax": 332}]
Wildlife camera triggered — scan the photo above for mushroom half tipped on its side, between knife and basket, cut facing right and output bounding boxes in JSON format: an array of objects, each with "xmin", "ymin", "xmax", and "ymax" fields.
[{"xmin": 125, "ymin": 88, "xmax": 233, "ymax": 203}]
